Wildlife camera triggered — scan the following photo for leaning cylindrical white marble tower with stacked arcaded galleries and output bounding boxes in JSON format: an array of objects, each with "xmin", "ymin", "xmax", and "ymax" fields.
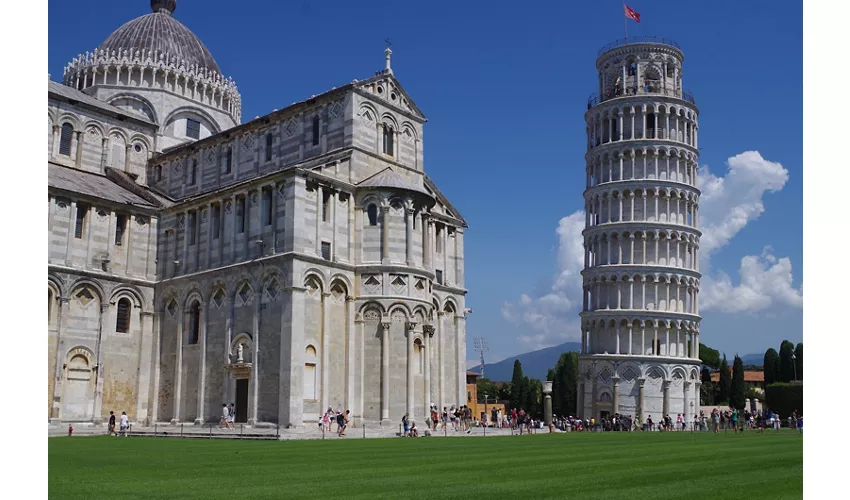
[{"xmin": 578, "ymin": 37, "xmax": 701, "ymax": 423}]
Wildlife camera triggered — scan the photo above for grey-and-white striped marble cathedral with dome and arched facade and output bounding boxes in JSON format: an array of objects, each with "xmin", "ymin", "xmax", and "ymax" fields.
[{"xmin": 47, "ymin": 0, "xmax": 468, "ymax": 427}]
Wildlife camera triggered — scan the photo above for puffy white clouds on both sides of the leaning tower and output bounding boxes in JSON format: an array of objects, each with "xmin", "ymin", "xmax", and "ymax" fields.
[{"xmin": 502, "ymin": 151, "xmax": 803, "ymax": 349}]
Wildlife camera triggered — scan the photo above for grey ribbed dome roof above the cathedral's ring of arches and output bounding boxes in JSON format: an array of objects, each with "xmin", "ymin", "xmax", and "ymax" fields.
[{"xmin": 98, "ymin": 0, "xmax": 221, "ymax": 74}]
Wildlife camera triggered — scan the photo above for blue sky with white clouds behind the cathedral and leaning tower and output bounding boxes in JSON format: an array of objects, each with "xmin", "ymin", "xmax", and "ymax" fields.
[{"xmin": 48, "ymin": 0, "xmax": 803, "ymax": 366}]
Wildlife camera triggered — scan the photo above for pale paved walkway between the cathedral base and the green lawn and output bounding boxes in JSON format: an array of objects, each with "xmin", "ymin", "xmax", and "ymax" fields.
[{"xmin": 48, "ymin": 424, "xmax": 548, "ymax": 440}]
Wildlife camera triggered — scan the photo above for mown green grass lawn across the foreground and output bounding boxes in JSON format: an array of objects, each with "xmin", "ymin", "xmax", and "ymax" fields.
[{"xmin": 48, "ymin": 432, "xmax": 803, "ymax": 500}]
